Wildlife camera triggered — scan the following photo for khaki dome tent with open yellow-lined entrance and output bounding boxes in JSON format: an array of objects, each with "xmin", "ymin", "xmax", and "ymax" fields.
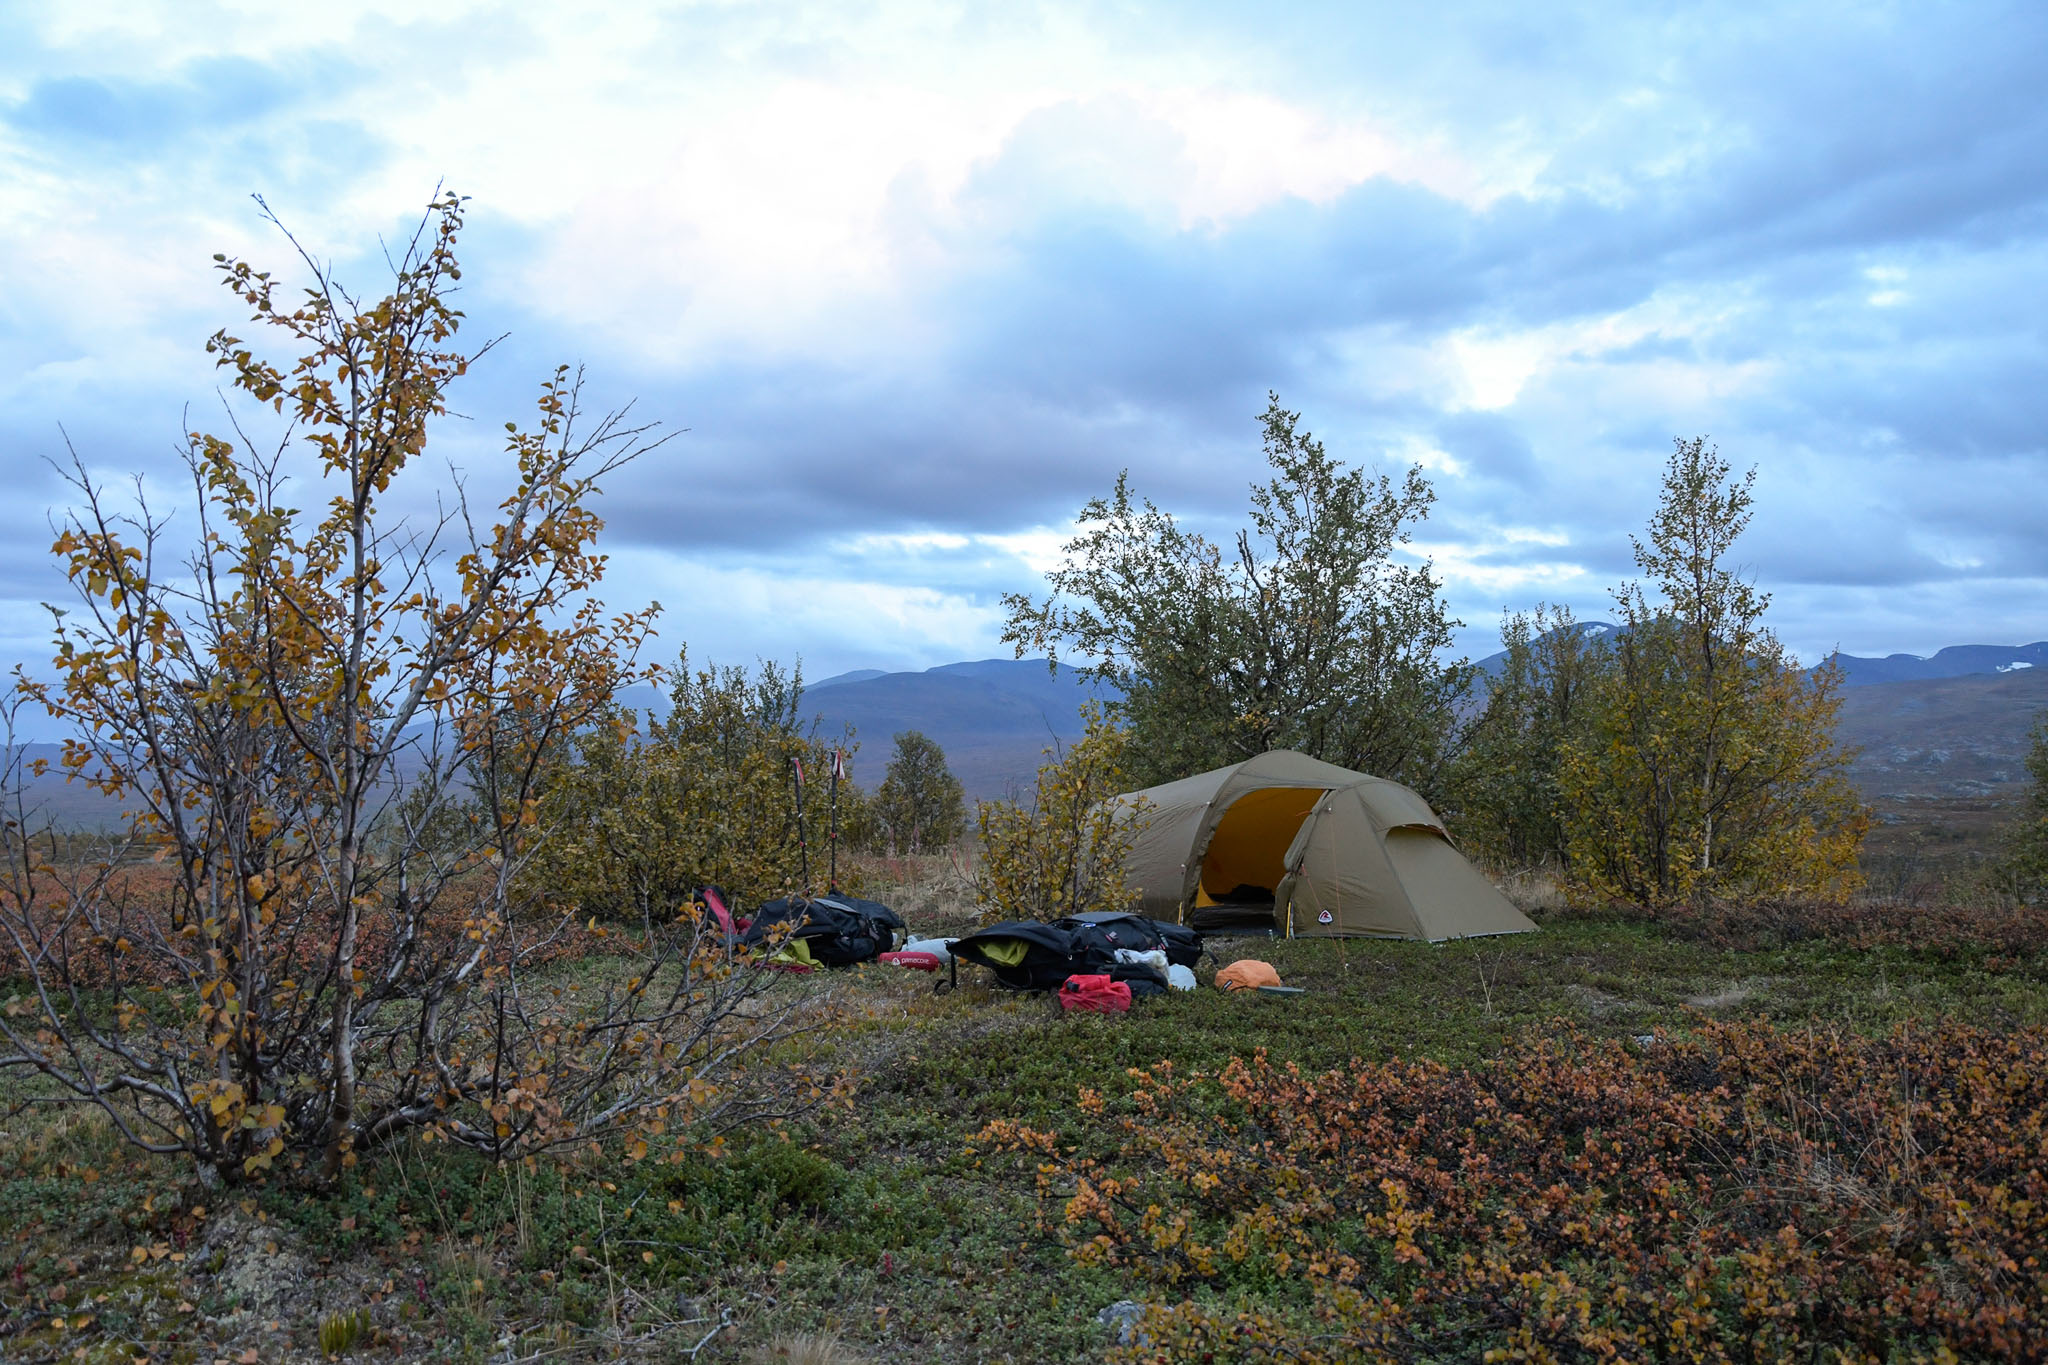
[{"xmin": 1116, "ymin": 749, "xmax": 1536, "ymax": 941}]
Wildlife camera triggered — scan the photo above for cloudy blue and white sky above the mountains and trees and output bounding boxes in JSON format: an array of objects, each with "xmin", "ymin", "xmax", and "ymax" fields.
[{"xmin": 0, "ymin": 0, "xmax": 2048, "ymax": 716}]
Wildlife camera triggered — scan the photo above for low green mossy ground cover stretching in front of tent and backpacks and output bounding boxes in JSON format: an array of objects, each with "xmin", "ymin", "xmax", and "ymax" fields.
[{"xmin": 0, "ymin": 921, "xmax": 2048, "ymax": 1361}]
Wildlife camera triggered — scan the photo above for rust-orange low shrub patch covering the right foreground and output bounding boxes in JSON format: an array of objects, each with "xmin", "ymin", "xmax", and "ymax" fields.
[{"xmin": 979, "ymin": 1023, "xmax": 2048, "ymax": 1361}]
